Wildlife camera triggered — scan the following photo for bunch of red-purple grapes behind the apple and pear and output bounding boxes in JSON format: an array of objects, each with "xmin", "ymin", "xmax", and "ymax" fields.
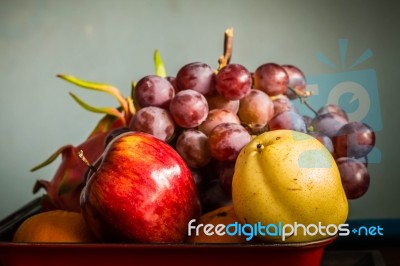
[{"xmin": 110, "ymin": 29, "xmax": 375, "ymax": 211}]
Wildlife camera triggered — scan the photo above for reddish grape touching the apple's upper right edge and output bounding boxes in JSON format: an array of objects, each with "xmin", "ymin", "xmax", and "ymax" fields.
[{"xmin": 175, "ymin": 129, "xmax": 211, "ymax": 168}]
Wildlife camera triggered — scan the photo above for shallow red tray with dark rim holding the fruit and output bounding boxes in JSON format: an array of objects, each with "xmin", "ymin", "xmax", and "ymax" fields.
[{"xmin": 0, "ymin": 199, "xmax": 336, "ymax": 266}]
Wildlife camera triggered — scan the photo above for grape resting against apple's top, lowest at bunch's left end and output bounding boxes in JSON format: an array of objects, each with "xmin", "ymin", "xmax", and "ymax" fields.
[{"xmin": 129, "ymin": 106, "xmax": 175, "ymax": 141}]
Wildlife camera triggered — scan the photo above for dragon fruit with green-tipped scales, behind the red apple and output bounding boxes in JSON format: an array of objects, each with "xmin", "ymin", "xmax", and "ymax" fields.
[{"xmin": 31, "ymin": 50, "xmax": 166, "ymax": 211}]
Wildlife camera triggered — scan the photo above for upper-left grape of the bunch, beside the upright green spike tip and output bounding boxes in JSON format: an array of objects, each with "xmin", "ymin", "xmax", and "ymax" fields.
[{"xmin": 134, "ymin": 75, "xmax": 175, "ymax": 109}]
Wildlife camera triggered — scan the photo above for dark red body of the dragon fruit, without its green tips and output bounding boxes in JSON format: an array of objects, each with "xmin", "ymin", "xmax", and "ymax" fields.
[{"xmin": 33, "ymin": 132, "xmax": 108, "ymax": 211}]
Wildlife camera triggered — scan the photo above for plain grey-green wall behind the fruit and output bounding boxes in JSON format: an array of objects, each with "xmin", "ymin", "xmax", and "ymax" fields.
[{"xmin": 0, "ymin": 0, "xmax": 400, "ymax": 218}]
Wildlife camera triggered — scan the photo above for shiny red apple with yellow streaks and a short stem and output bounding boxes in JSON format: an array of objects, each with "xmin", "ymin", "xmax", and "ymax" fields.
[{"xmin": 81, "ymin": 132, "xmax": 201, "ymax": 243}]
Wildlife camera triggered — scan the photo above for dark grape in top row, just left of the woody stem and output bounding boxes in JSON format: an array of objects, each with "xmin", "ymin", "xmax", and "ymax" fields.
[{"xmin": 176, "ymin": 62, "xmax": 214, "ymax": 95}]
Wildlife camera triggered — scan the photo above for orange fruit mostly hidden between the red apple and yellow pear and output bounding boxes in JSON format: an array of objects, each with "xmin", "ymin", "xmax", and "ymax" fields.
[{"xmin": 186, "ymin": 205, "xmax": 247, "ymax": 243}]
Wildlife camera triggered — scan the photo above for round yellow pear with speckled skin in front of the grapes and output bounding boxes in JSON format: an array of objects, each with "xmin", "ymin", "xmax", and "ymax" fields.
[{"xmin": 232, "ymin": 130, "xmax": 348, "ymax": 242}]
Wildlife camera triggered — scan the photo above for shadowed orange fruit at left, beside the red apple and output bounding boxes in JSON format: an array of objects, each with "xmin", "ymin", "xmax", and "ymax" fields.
[{"xmin": 13, "ymin": 210, "xmax": 96, "ymax": 243}]
